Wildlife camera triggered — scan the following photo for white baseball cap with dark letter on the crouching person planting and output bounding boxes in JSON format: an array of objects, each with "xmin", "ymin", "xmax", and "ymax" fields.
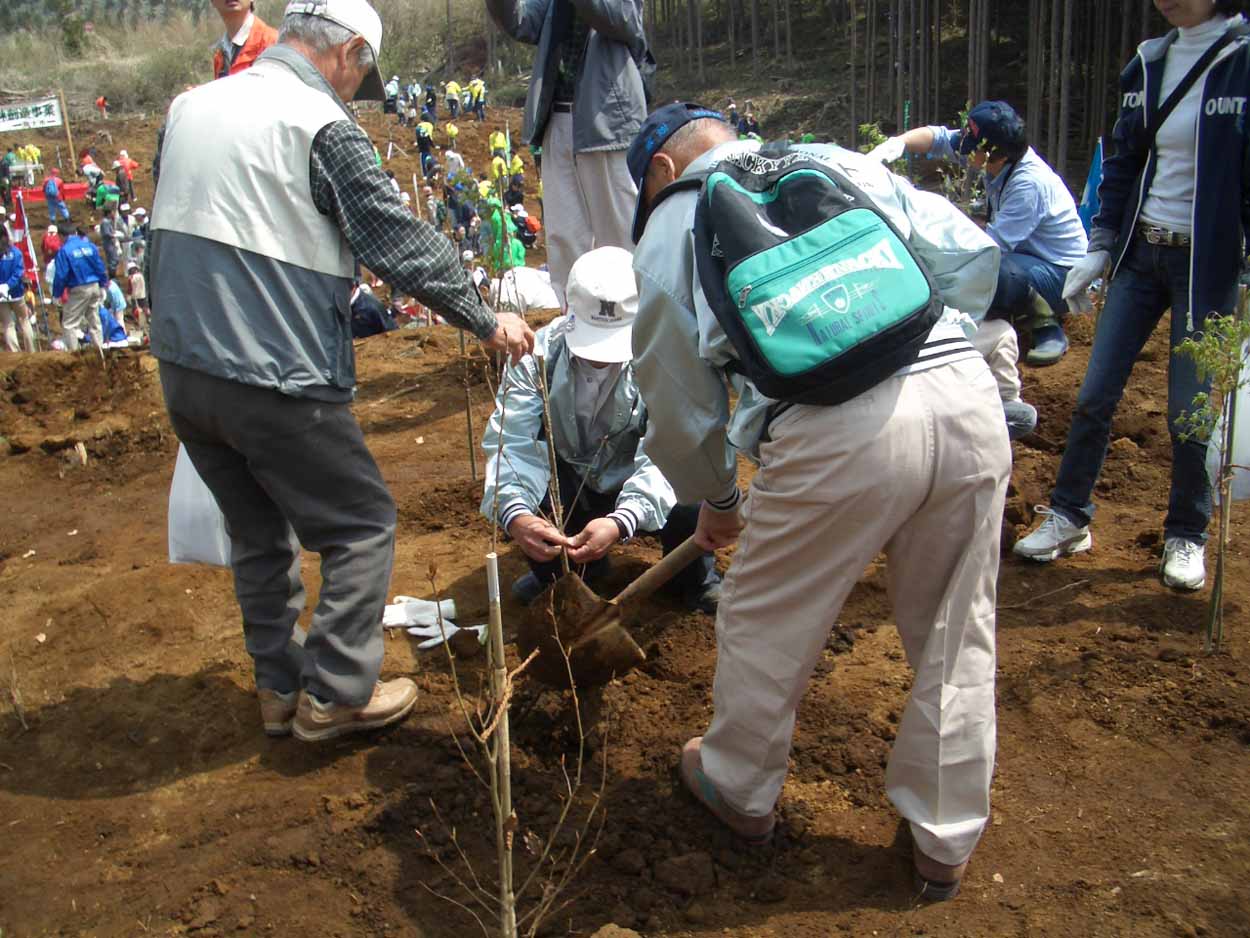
[{"xmin": 565, "ymin": 248, "xmax": 638, "ymax": 364}]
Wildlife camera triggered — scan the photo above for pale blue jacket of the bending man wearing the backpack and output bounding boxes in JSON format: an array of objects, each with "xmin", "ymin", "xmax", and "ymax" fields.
[{"xmin": 634, "ymin": 141, "xmax": 1000, "ymax": 504}]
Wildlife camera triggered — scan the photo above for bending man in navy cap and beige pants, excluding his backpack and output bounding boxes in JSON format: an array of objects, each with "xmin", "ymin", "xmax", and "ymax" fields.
[{"xmin": 630, "ymin": 104, "xmax": 1011, "ymax": 899}]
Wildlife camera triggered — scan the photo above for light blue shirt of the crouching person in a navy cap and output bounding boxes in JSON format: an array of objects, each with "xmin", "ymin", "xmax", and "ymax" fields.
[{"xmin": 929, "ymin": 126, "xmax": 1089, "ymax": 268}]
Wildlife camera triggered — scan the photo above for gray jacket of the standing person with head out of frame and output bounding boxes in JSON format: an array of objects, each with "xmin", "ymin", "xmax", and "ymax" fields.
[{"xmin": 486, "ymin": 0, "xmax": 649, "ymax": 153}]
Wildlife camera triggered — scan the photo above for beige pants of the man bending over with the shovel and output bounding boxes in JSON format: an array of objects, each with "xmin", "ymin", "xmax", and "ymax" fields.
[{"xmin": 703, "ymin": 359, "xmax": 1011, "ymax": 864}]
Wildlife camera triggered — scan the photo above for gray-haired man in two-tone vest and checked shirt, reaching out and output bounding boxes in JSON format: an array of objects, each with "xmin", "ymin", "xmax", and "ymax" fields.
[{"xmin": 149, "ymin": 0, "xmax": 534, "ymax": 740}]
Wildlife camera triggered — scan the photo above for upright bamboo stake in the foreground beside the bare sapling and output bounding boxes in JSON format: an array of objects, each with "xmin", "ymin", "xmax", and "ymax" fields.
[{"xmin": 486, "ymin": 552, "xmax": 516, "ymax": 938}]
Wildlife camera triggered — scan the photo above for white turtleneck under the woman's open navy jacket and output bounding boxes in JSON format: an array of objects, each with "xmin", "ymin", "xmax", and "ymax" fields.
[{"xmin": 1141, "ymin": 16, "xmax": 1229, "ymax": 234}]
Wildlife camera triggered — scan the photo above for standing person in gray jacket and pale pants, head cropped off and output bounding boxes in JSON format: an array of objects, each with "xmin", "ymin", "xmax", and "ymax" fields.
[{"xmin": 486, "ymin": 0, "xmax": 654, "ymax": 304}]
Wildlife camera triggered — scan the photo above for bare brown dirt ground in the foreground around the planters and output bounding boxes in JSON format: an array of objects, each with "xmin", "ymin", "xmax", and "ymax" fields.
[{"xmin": 0, "ymin": 106, "xmax": 1250, "ymax": 938}]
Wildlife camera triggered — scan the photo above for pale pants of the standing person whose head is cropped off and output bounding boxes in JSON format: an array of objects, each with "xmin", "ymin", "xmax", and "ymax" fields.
[{"xmin": 543, "ymin": 114, "xmax": 638, "ymax": 306}]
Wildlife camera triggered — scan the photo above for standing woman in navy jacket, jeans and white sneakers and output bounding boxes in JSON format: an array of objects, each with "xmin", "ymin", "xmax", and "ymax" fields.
[{"xmin": 1015, "ymin": 0, "xmax": 1250, "ymax": 589}]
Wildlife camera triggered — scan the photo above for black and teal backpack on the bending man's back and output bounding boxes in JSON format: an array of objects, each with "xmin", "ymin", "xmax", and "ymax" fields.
[{"xmin": 653, "ymin": 145, "xmax": 943, "ymax": 405}]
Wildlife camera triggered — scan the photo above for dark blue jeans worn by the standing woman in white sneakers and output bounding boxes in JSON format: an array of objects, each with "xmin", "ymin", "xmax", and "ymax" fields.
[{"xmin": 1050, "ymin": 235, "xmax": 1236, "ymax": 544}]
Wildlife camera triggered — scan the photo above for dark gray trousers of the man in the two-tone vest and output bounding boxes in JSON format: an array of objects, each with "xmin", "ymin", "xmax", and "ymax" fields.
[{"xmin": 160, "ymin": 361, "xmax": 395, "ymax": 707}]
